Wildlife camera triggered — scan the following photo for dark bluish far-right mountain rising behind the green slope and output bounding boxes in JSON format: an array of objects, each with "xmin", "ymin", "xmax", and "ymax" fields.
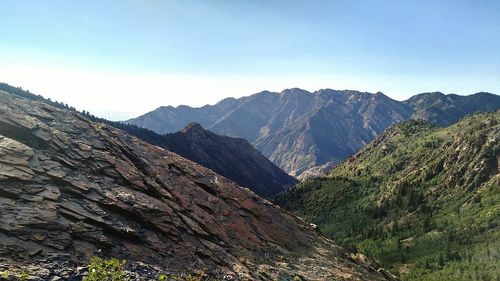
[{"xmin": 403, "ymin": 92, "xmax": 500, "ymax": 126}]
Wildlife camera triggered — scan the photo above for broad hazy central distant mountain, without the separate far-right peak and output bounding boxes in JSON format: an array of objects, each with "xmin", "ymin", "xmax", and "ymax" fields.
[{"xmin": 127, "ymin": 89, "xmax": 412, "ymax": 176}]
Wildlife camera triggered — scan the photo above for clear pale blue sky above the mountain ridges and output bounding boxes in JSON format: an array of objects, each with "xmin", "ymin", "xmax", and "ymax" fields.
[{"xmin": 0, "ymin": 0, "xmax": 500, "ymax": 120}]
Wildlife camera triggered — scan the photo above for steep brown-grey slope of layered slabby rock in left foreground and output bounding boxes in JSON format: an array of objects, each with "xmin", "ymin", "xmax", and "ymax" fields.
[{"xmin": 0, "ymin": 92, "xmax": 389, "ymax": 280}]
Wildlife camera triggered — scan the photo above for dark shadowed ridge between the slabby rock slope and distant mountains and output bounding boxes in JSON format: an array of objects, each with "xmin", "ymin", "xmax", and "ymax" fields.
[{"xmin": 0, "ymin": 83, "xmax": 297, "ymax": 197}]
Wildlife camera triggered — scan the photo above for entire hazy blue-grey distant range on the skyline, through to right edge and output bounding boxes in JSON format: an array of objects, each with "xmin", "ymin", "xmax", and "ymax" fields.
[{"xmin": 126, "ymin": 88, "xmax": 500, "ymax": 178}]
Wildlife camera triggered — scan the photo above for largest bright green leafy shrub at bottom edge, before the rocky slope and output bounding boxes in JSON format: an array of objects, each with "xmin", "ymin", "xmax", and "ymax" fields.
[{"xmin": 83, "ymin": 257, "xmax": 126, "ymax": 281}]
